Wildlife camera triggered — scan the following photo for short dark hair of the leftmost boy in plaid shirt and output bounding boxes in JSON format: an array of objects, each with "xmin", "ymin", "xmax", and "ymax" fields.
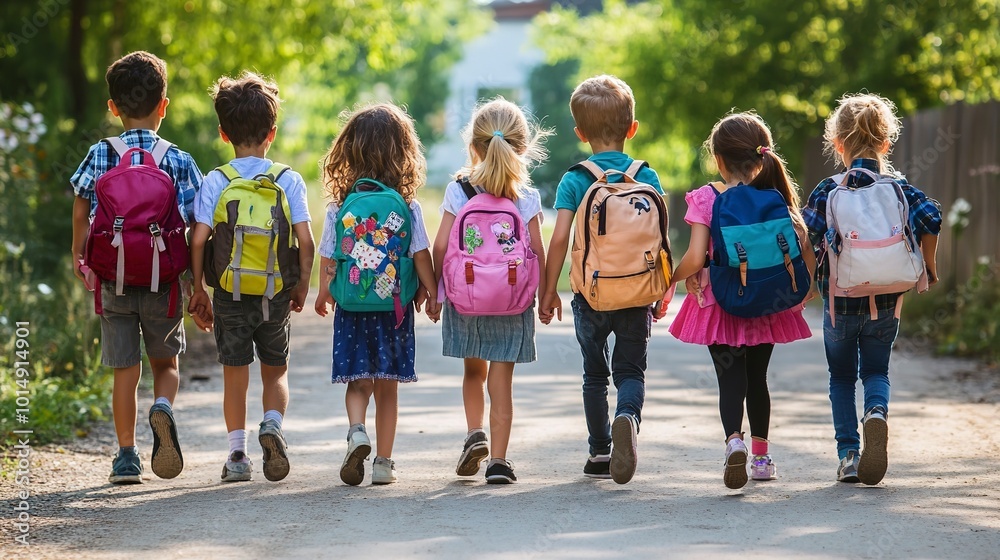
[{"xmin": 104, "ymin": 51, "xmax": 167, "ymax": 119}]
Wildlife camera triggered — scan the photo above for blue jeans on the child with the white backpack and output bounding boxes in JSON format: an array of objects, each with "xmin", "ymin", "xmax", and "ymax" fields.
[{"xmin": 823, "ymin": 305, "xmax": 899, "ymax": 459}]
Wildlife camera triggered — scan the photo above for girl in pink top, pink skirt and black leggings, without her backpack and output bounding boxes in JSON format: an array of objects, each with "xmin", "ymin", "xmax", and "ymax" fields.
[{"xmin": 670, "ymin": 113, "xmax": 812, "ymax": 488}]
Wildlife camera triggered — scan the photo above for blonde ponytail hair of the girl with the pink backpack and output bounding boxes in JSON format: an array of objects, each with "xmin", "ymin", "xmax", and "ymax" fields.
[{"xmin": 458, "ymin": 97, "xmax": 551, "ymax": 200}]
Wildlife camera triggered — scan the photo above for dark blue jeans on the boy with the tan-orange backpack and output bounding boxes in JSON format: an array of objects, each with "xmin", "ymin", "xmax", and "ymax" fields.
[{"xmin": 573, "ymin": 294, "xmax": 653, "ymax": 455}]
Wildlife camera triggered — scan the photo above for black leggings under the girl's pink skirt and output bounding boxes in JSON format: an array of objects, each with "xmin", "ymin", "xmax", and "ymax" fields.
[{"xmin": 708, "ymin": 344, "xmax": 774, "ymax": 439}]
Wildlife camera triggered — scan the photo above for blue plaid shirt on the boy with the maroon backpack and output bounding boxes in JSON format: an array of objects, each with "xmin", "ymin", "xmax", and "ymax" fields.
[{"xmin": 69, "ymin": 129, "xmax": 203, "ymax": 225}]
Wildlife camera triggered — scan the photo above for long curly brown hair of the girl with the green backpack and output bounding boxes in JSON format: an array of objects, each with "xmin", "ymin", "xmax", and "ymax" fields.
[{"xmin": 322, "ymin": 103, "xmax": 427, "ymax": 204}]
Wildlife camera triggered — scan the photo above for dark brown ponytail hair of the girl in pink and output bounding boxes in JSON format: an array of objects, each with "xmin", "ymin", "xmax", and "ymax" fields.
[{"xmin": 705, "ymin": 112, "xmax": 804, "ymax": 226}]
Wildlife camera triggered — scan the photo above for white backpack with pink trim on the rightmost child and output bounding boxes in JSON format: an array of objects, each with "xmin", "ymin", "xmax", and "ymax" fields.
[{"xmin": 826, "ymin": 168, "xmax": 928, "ymax": 319}]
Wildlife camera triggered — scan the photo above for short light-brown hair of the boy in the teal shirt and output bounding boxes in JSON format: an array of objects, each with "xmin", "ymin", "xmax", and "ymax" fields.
[{"xmin": 569, "ymin": 75, "xmax": 635, "ymax": 148}]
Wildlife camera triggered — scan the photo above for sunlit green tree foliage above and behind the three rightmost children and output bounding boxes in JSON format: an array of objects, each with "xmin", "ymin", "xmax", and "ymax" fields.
[{"xmin": 536, "ymin": 0, "xmax": 1000, "ymax": 189}]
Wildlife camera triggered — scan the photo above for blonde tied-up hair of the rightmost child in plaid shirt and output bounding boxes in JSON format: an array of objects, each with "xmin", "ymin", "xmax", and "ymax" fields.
[{"xmin": 823, "ymin": 93, "xmax": 902, "ymax": 173}]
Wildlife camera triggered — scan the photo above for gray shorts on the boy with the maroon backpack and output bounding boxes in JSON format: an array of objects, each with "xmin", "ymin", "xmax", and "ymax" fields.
[{"xmin": 101, "ymin": 282, "xmax": 185, "ymax": 369}]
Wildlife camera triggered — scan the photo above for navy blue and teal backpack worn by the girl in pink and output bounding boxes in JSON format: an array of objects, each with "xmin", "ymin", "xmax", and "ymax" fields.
[{"xmin": 709, "ymin": 183, "xmax": 810, "ymax": 318}]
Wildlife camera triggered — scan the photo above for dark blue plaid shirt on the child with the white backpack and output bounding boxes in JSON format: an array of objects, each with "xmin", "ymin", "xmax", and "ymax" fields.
[{"xmin": 802, "ymin": 158, "xmax": 941, "ymax": 314}]
